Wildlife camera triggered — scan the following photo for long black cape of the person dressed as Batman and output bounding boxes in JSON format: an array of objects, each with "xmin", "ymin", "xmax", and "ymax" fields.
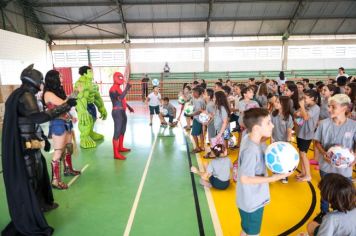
[{"xmin": 1, "ymin": 88, "xmax": 53, "ymax": 236}]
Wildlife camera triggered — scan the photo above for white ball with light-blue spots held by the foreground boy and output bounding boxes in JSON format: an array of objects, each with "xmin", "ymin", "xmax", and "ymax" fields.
[{"xmin": 265, "ymin": 142, "xmax": 299, "ymax": 174}]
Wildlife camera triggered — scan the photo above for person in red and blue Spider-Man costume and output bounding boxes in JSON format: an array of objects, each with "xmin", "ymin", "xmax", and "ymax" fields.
[{"xmin": 109, "ymin": 72, "xmax": 134, "ymax": 160}]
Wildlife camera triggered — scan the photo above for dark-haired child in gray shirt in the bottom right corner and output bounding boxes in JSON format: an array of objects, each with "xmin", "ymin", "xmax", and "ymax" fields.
[{"xmin": 307, "ymin": 173, "xmax": 356, "ymax": 236}]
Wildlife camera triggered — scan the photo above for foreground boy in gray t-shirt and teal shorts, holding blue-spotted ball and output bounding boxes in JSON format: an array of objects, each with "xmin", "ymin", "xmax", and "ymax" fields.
[{"xmin": 236, "ymin": 108, "xmax": 291, "ymax": 235}]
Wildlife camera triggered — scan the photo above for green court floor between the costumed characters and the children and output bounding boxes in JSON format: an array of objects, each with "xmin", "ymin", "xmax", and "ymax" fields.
[{"xmin": 0, "ymin": 103, "xmax": 214, "ymax": 236}]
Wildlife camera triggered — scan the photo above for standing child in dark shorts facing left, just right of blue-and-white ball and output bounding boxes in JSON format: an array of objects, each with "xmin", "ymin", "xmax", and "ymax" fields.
[{"xmin": 294, "ymin": 90, "xmax": 320, "ymax": 181}]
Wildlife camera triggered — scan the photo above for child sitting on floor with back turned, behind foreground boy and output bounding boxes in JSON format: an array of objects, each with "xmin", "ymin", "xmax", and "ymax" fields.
[{"xmin": 191, "ymin": 144, "xmax": 232, "ymax": 190}]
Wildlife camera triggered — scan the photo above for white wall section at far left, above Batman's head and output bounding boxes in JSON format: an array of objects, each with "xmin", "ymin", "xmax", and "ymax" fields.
[{"xmin": 0, "ymin": 30, "xmax": 52, "ymax": 85}]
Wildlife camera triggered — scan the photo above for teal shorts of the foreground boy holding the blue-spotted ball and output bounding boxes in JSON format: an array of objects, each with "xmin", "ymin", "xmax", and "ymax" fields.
[{"xmin": 239, "ymin": 207, "xmax": 264, "ymax": 235}]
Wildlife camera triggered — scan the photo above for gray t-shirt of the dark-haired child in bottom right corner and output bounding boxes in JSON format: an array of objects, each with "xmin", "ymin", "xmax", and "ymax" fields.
[{"xmin": 316, "ymin": 208, "xmax": 356, "ymax": 236}]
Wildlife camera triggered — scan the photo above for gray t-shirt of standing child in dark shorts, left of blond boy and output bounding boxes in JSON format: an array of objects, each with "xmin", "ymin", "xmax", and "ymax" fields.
[{"xmin": 297, "ymin": 104, "xmax": 320, "ymax": 140}]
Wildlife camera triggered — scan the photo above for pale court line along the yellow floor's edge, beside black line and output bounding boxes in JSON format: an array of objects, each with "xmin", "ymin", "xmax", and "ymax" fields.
[{"xmin": 188, "ymin": 134, "xmax": 223, "ymax": 236}]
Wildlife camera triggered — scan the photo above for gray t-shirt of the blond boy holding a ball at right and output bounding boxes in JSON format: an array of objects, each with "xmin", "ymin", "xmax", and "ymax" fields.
[{"xmin": 314, "ymin": 118, "xmax": 356, "ymax": 178}]
